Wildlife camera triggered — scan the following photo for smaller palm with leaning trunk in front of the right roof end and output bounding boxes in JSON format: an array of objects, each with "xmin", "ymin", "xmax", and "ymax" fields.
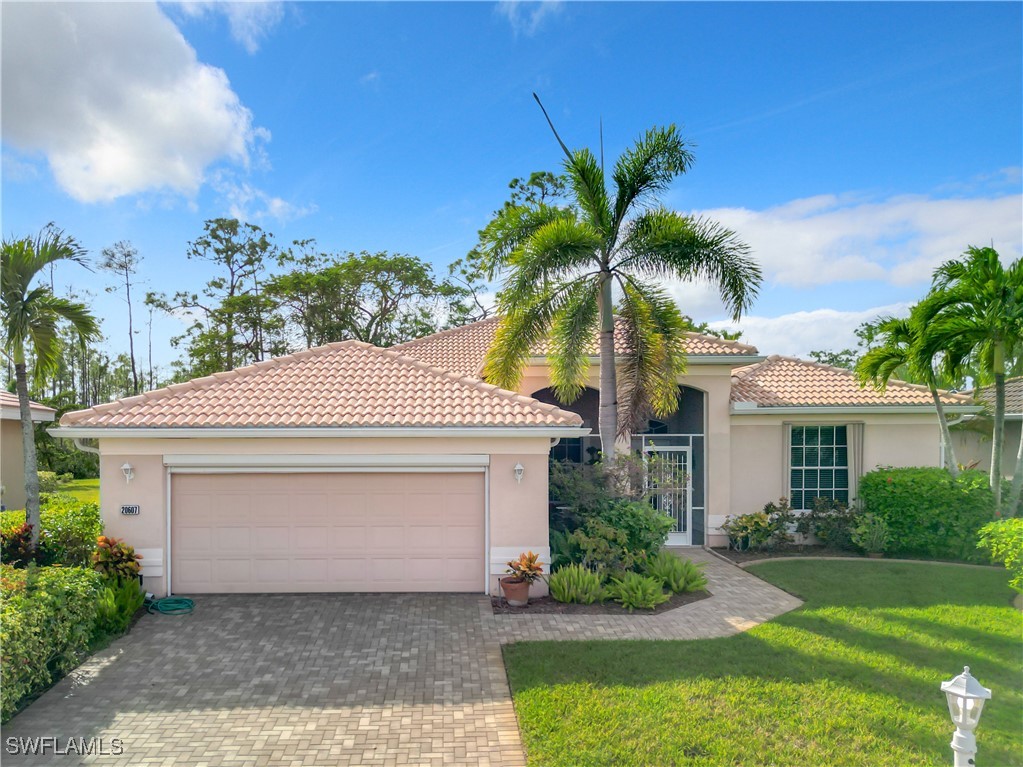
[{"xmin": 856, "ymin": 307, "xmax": 959, "ymax": 477}]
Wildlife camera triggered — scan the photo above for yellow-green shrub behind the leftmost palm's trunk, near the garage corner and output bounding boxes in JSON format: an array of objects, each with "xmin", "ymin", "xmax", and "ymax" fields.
[{"xmin": 0, "ymin": 493, "xmax": 103, "ymax": 568}]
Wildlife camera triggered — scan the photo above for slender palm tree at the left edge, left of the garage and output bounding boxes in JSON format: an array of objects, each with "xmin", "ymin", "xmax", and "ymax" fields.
[{"xmin": 0, "ymin": 224, "xmax": 99, "ymax": 546}]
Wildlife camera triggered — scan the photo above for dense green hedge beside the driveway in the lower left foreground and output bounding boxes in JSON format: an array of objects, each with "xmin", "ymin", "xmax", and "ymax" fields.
[{"xmin": 0, "ymin": 566, "xmax": 102, "ymax": 721}]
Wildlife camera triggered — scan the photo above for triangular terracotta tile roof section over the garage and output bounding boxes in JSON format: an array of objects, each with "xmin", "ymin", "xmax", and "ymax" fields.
[{"xmin": 60, "ymin": 341, "xmax": 582, "ymax": 427}]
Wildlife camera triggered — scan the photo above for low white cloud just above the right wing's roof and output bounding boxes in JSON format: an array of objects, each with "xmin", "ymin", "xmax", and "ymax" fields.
[{"xmin": 709, "ymin": 303, "xmax": 909, "ymax": 358}]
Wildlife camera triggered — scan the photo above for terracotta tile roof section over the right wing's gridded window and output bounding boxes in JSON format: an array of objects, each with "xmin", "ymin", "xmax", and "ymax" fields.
[{"xmin": 731, "ymin": 355, "xmax": 973, "ymax": 407}]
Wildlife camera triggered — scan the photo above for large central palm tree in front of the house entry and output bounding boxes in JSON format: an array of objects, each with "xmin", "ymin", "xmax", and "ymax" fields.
[{"xmin": 481, "ymin": 102, "xmax": 760, "ymax": 460}]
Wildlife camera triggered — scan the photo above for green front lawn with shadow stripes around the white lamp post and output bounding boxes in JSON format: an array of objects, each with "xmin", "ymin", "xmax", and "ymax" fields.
[{"xmin": 504, "ymin": 560, "xmax": 1023, "ymax": 767}]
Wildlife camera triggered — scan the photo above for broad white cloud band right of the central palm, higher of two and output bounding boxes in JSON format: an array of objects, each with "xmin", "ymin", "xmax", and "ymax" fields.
[{"xmin": 698, "ymin": 191, "xmax": 1023, "ymax": 287}]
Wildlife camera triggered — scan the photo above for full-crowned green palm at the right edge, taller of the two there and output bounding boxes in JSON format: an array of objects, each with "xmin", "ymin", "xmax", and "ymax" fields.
[{"xmin": 917, "ymin": 247, "xmax": 1023, "ymax": 514}]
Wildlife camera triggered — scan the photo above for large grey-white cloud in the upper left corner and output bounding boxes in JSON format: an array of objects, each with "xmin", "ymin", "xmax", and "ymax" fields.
[{"xmin": 2, "ymin": 2, "xmax": 269, "ymax": 202}]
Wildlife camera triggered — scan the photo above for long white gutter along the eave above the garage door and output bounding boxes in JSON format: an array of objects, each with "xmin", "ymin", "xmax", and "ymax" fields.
[{"xmin": 46, "ymin": 426, "xmax": 591, "ymax": 440}]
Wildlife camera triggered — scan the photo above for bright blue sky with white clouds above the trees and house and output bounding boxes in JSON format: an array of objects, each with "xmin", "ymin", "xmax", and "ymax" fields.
[{"xmin": 2, "ymin": 2, "xmax": 1023, "ymax": 372}]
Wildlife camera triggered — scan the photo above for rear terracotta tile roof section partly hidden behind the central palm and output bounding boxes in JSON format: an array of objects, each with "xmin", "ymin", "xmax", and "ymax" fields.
[{"xmin": 394, "ymin": 317, "xmax": 758, "ymax": 377}]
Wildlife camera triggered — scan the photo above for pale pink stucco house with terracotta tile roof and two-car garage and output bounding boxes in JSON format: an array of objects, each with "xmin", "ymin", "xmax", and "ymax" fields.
[{"xmin": 53, "ymin": 319, "xmax": 977, "ymax": 593}]
